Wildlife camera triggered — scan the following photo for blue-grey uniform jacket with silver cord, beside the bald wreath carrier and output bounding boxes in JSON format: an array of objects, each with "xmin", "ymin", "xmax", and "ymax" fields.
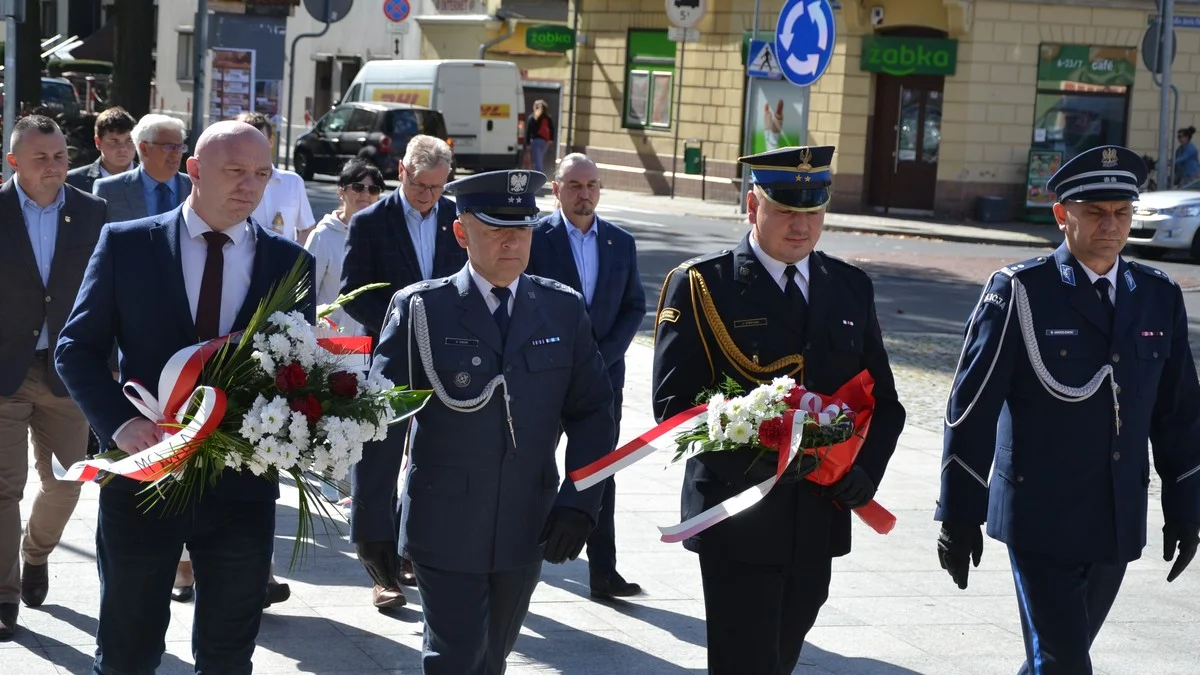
[{"xmin": 350, "ymin": 267, "xmax": 616, "ymax": 574}]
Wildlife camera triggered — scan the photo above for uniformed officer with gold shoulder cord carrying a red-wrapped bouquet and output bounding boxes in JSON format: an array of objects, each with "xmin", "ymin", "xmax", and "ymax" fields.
[{"xmin": 653, "ymin": 147, "xmax": 905, "ymax": 675}]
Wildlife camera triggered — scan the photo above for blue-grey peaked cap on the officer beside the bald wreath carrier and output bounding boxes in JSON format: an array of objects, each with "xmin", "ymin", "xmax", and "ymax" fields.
[{"xmin": 445, "ymin": 171, "xmax": 546, "ymax": 227}]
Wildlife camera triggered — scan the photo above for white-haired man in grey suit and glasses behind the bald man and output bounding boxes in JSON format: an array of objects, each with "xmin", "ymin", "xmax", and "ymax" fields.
[{"xmin": 91, "ymin": 114, "xmax": 192, "ymax": 222}]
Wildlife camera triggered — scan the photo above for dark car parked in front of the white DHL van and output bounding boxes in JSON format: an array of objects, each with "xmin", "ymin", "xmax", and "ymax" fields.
[{"xmin": 293, "ymin": 101, "xmax": 454, "ymax": 180}]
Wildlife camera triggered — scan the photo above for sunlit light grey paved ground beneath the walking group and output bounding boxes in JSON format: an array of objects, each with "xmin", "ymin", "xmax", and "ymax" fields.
[{"xmin": 0, "ymin": 342, "xmax": 1200, "ymax": 675}]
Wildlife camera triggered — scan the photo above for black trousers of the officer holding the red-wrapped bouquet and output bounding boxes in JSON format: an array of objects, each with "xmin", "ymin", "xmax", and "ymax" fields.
[{"xmin": 700, "ymin": 551, "xmax": 833, "ymax": 675}]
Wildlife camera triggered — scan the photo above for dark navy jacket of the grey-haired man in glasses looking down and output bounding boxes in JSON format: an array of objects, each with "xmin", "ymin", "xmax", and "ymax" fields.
[{"xmin": 342, "ymin": 189, "xmax": 467, "ymax": 340}]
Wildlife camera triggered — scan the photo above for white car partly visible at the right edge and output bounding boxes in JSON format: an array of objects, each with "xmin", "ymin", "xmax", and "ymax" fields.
[{"xmin": 1129, "ymin": 184, "xmax": 1200, "ymax": 261}]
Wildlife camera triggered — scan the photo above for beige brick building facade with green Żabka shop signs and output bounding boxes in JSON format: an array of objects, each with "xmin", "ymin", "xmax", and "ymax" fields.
[{"xmin": 561, "ymin": 0, "xmax": 1200, "ymax": 217}]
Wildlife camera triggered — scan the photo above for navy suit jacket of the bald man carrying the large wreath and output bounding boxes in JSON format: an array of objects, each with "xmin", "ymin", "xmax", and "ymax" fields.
[{"xmin": 54, "ymin": 205, "xmax": 316, "ymax": 500}]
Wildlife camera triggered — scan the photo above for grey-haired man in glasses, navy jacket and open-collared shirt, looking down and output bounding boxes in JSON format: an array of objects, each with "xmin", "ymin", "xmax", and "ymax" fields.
[{"xmin": 342, "ymin": 135, "xmax": 467, "ymax": 609}]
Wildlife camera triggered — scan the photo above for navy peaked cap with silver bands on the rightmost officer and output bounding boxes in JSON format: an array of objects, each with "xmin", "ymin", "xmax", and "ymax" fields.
[{"xmin": 1046, "ymin": 145, "xmax": 1147, "ymax": 202}]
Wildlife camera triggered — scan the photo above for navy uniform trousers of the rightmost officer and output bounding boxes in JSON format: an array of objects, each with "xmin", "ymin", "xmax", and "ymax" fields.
[{"xmin": 1008, "ymin": 546, "xmax": 1126, "ymax": 675}]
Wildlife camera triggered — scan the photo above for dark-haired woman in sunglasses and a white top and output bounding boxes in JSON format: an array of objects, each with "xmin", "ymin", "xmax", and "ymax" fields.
[{"xmin": 305, "ymin": 159, "xmax": 384, "ymax": 335}]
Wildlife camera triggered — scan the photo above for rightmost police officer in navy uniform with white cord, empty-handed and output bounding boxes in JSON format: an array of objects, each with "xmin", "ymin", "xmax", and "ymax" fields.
[{"xmin": 936, "ymin": 145, "xmax": 1200, "ymax": 675}]
